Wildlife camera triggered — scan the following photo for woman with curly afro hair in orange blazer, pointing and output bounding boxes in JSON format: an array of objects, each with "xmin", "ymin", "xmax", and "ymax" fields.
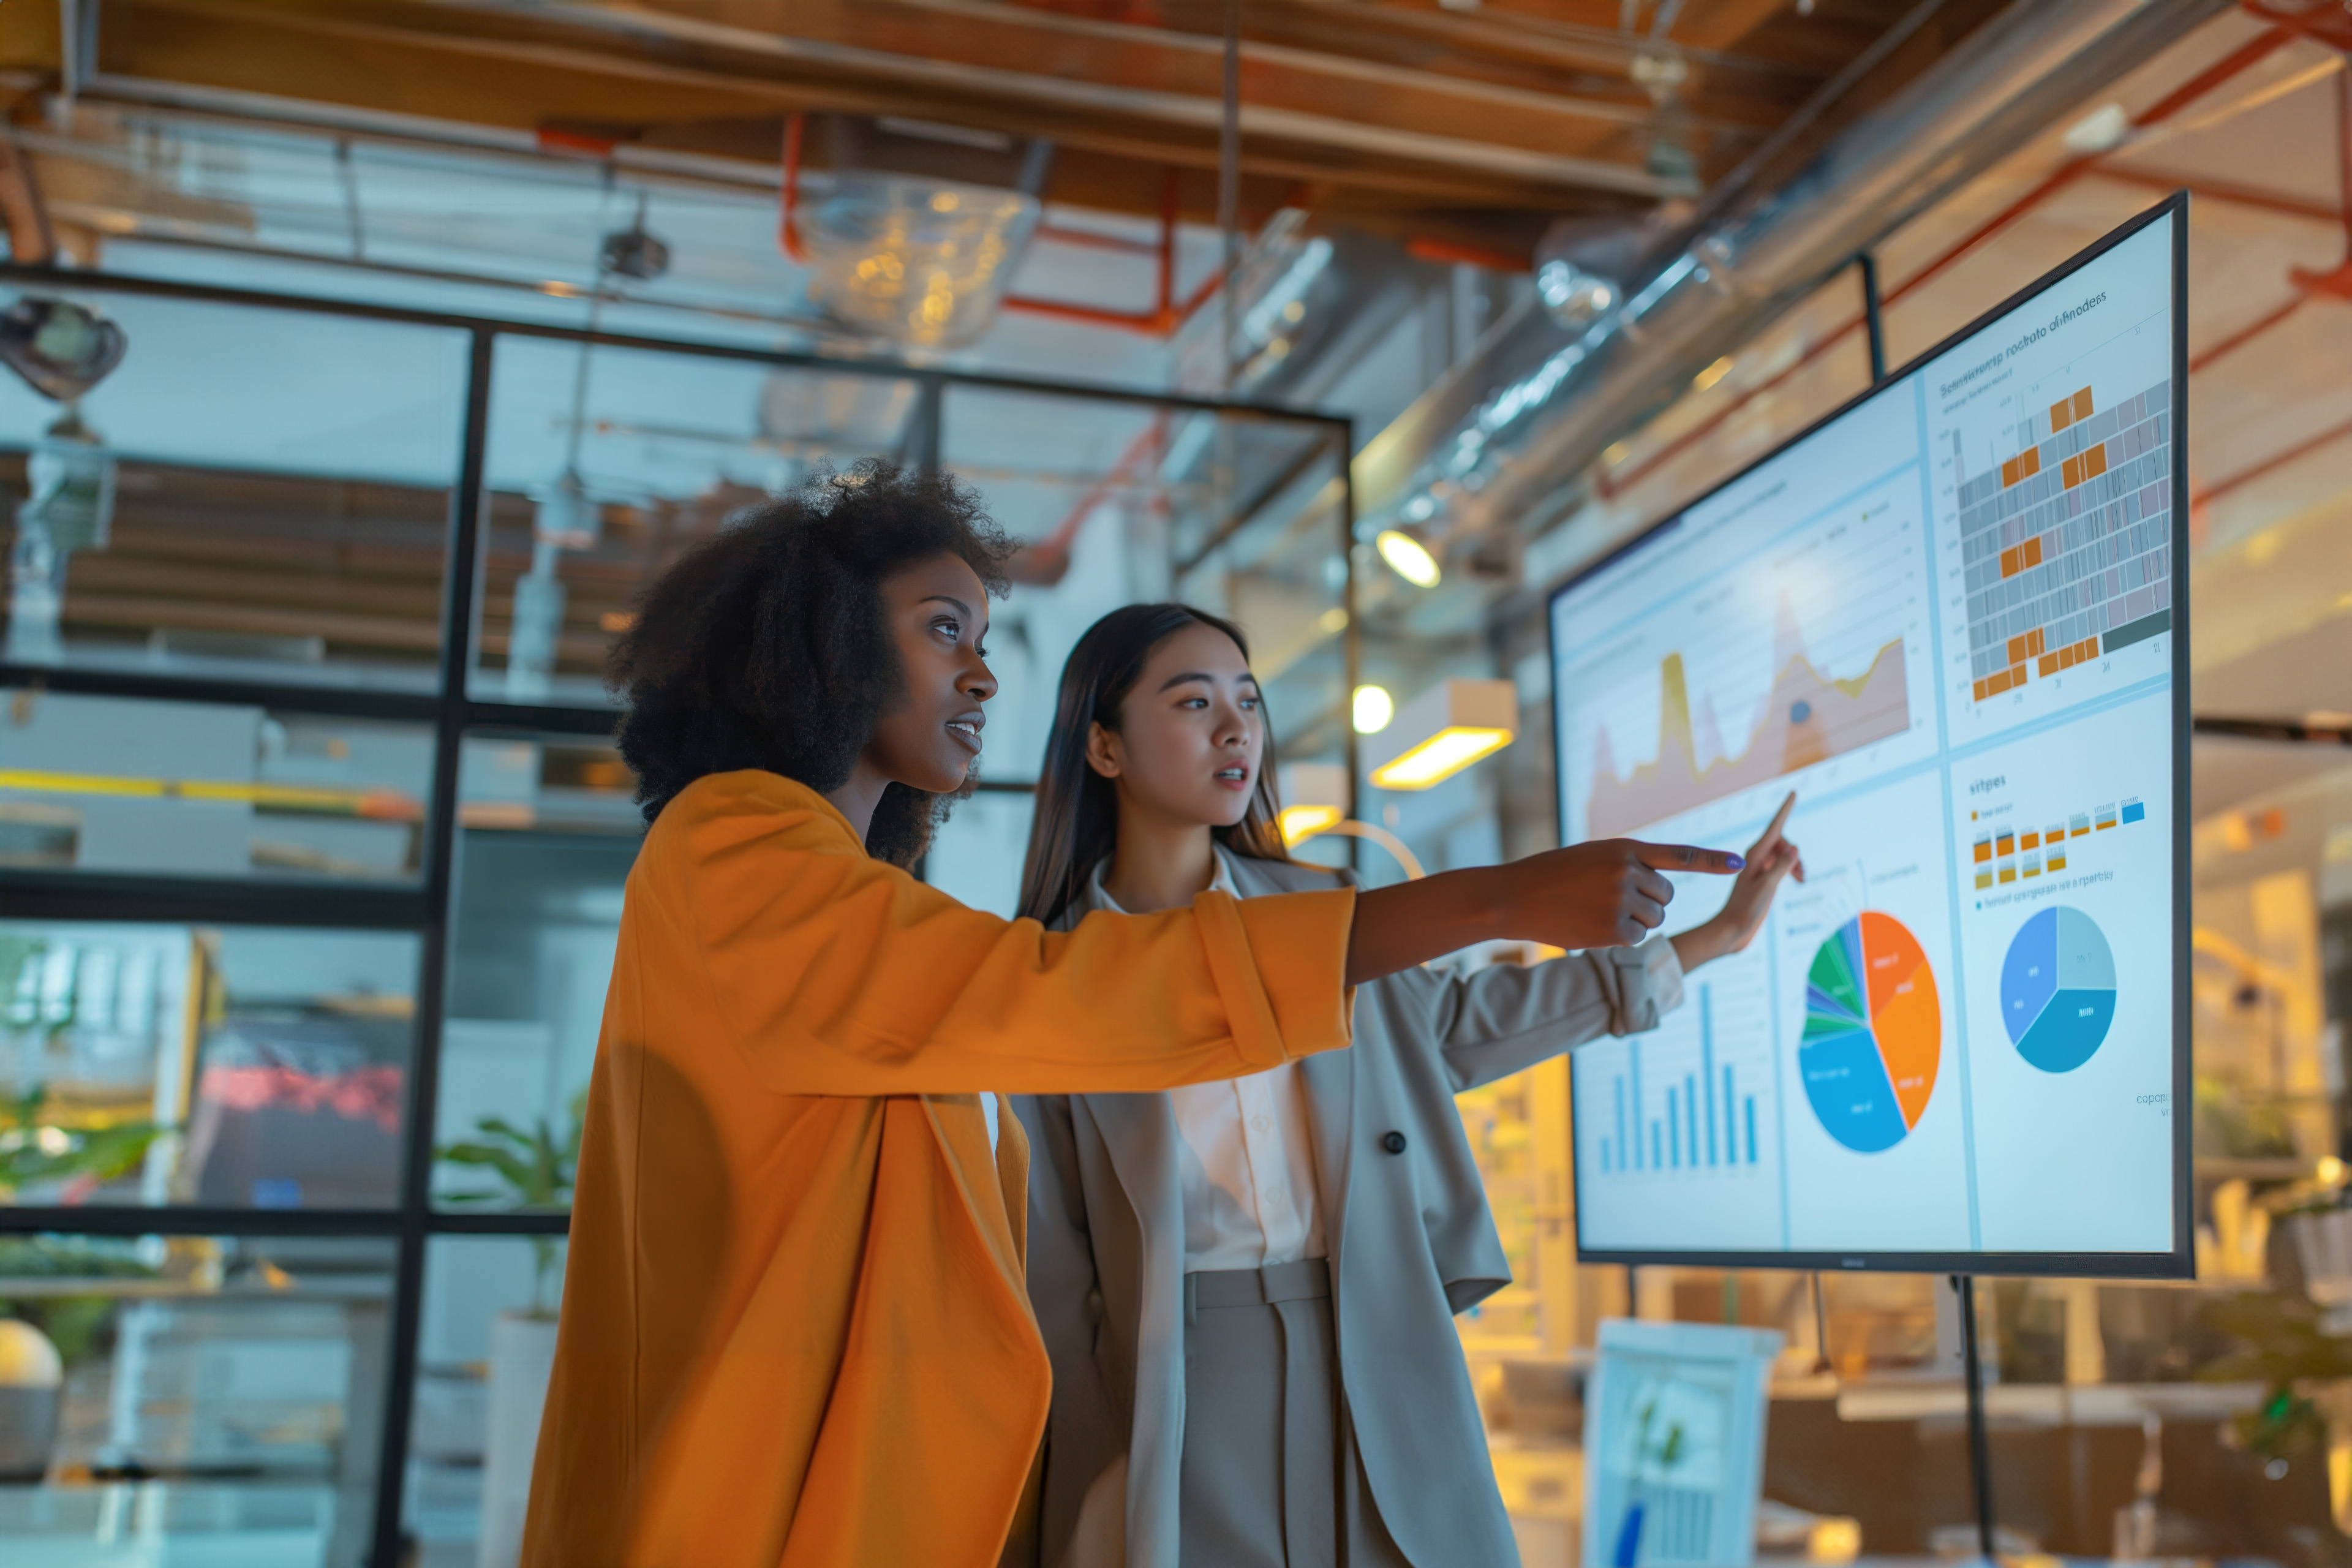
[{"xmin": 522, "ymin": 463, "xmax": 1736, "ymax": 1568}]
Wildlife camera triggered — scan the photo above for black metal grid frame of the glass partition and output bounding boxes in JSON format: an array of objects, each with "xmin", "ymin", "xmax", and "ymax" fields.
[{"xmin": 0, "ymin": 263, "xmax": 1362, "ymax": 1568}]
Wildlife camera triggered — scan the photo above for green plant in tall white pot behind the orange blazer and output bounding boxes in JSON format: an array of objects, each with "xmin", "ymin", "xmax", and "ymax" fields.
[{"xmin": 433, "ymin": 1088, "xmax": 588, "ymax": 1568}]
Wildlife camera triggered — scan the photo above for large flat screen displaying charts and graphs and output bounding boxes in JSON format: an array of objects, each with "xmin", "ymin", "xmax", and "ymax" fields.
[{"xmin": 1550, "ymin": 197, "xmax": 2192, "ymax": 1276}]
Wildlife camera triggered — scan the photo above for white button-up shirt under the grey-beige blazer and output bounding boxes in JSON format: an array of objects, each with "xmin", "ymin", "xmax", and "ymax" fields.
[{"xmin": 1091, "ymin": 849, "xmax": 1324, "ymax": 1274}]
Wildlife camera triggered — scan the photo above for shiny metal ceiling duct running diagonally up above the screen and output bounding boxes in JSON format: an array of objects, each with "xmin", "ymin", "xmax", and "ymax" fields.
[{"xmin": 1355, "ymin": 0, "xmax": 2230, "ymax": 557}]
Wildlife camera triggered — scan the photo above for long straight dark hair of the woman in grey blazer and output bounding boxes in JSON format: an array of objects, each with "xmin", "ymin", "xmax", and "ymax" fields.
[{"xmin": 1021, "ymin": 604, "xmax": 1291, "ymax": 924}]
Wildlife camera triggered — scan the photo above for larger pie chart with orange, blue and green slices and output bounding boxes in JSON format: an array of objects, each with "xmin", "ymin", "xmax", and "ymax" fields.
[{"xmin": 1797, "ymin": 910, "xmax": 1943, "ymax": 1154}]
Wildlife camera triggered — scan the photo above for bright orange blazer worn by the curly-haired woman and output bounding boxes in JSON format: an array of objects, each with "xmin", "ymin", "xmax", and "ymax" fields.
[{"xmin": 522, "ymin": 771, "xmax": 1355, "ymax": 1568}]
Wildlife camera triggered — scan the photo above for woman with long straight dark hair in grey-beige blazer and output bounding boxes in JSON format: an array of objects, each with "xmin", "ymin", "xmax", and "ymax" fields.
[{"xmin": 1014, "ymin": 604, "xmax": 1801, "ymax": 1568}]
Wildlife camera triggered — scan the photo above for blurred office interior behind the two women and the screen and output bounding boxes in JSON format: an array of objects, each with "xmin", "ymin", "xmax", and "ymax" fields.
[{"xmin": 0, "ymin": 0, "xmax": 2352, "ymax": 1568}]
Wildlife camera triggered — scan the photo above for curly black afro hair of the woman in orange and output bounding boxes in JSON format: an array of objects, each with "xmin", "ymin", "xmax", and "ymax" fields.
[{"xmin": 607, "ymin": 458, "xmax": 1014, "ymax": 865}]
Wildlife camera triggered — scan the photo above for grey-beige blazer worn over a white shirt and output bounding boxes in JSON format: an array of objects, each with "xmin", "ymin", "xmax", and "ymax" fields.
[{"xmin": 1014, "ymin": 856, "xmax": 1682, "ymax": 1568}]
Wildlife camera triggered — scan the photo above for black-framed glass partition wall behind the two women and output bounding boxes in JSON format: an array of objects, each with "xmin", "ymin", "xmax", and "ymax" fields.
[{"xmin": 0, "ymin": 268, "xmax": 1357, "ymax": 1568}]
